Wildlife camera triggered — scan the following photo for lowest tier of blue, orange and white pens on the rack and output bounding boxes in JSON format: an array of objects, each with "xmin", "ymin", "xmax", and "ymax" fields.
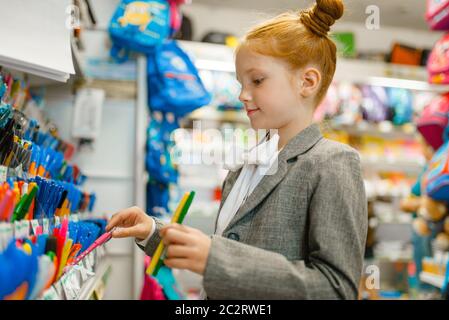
[{"xmin": 0, "ymin": 218, "xmax": 106, "ymax": 299}]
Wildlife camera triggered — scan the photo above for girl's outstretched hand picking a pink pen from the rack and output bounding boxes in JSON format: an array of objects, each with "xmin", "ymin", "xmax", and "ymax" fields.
[{"xmin": 106, "ymin": 207, "xmax": 153, "ymax": 240}]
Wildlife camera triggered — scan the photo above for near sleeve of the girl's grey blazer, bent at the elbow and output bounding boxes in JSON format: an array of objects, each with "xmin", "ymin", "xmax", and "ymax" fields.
[{"xmin": 203, "ymin": 150, "xmax": 368, "ymax": 299}]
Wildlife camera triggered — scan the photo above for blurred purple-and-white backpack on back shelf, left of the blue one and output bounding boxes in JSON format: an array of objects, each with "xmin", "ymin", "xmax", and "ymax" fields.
[{"xmin": 362, "ymin": 86, "xmax": 390, "ymax": 122}]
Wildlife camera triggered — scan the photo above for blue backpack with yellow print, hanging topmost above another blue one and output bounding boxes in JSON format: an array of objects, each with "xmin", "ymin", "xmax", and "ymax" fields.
[{"xmin": 109, "ymin": 0, "xmax": 171, "ymax": 62}]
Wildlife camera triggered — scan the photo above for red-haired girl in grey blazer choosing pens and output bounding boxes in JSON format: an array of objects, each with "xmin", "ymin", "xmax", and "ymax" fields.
[{"xmin": 107, "ymin": 0, "xmax": 367, "ymax": 299}]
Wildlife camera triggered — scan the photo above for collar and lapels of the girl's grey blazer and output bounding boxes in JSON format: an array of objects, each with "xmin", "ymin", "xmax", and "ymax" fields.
[{"xmin": 220, "ymin": 124, "xmax": 322, "ymax": 233}]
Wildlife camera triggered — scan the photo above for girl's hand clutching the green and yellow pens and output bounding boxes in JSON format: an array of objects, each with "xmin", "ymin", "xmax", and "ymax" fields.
[{"xmin": 160, "ymin": 224, "xmax": 211, "ymax": 275}]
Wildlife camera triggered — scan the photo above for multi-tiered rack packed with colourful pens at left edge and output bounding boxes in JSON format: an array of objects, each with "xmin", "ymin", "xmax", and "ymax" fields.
[{"xmin": 0, "ymin": 68, "xmax": 110, "ymax": 300}]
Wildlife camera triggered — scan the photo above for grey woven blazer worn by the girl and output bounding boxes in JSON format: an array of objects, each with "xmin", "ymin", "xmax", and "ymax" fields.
[{"xmin": 143, "ymin": 124, "xmax": 368, "ymax": 299}]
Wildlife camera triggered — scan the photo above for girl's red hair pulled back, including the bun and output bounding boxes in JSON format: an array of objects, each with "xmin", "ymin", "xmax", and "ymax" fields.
[{"xmin": 237, "ymin": 0, "xmax": 344, "ymax": 105}]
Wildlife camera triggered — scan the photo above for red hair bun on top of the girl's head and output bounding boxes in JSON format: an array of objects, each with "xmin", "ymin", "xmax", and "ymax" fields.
[{"xmin": 299, "ymin": 0, "xmax": 344, "ymax": 37}]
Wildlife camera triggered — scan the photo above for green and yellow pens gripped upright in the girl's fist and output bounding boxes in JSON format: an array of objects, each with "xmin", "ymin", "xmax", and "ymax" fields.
[{"xmin": 146, "ymin": 191, "xmax": 195, "ymax": 276}]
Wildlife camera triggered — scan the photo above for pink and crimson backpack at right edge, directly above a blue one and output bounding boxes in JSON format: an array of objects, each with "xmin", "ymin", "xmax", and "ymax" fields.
[{"xmin": 416, "ymin": 94, "xmax": 449, "ymax": 150}]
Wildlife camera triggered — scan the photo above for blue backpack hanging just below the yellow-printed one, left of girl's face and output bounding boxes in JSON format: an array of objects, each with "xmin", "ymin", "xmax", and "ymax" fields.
[{"xmin": 148, "ymin": 40, "xmax": 211, "ymax": 117}]
